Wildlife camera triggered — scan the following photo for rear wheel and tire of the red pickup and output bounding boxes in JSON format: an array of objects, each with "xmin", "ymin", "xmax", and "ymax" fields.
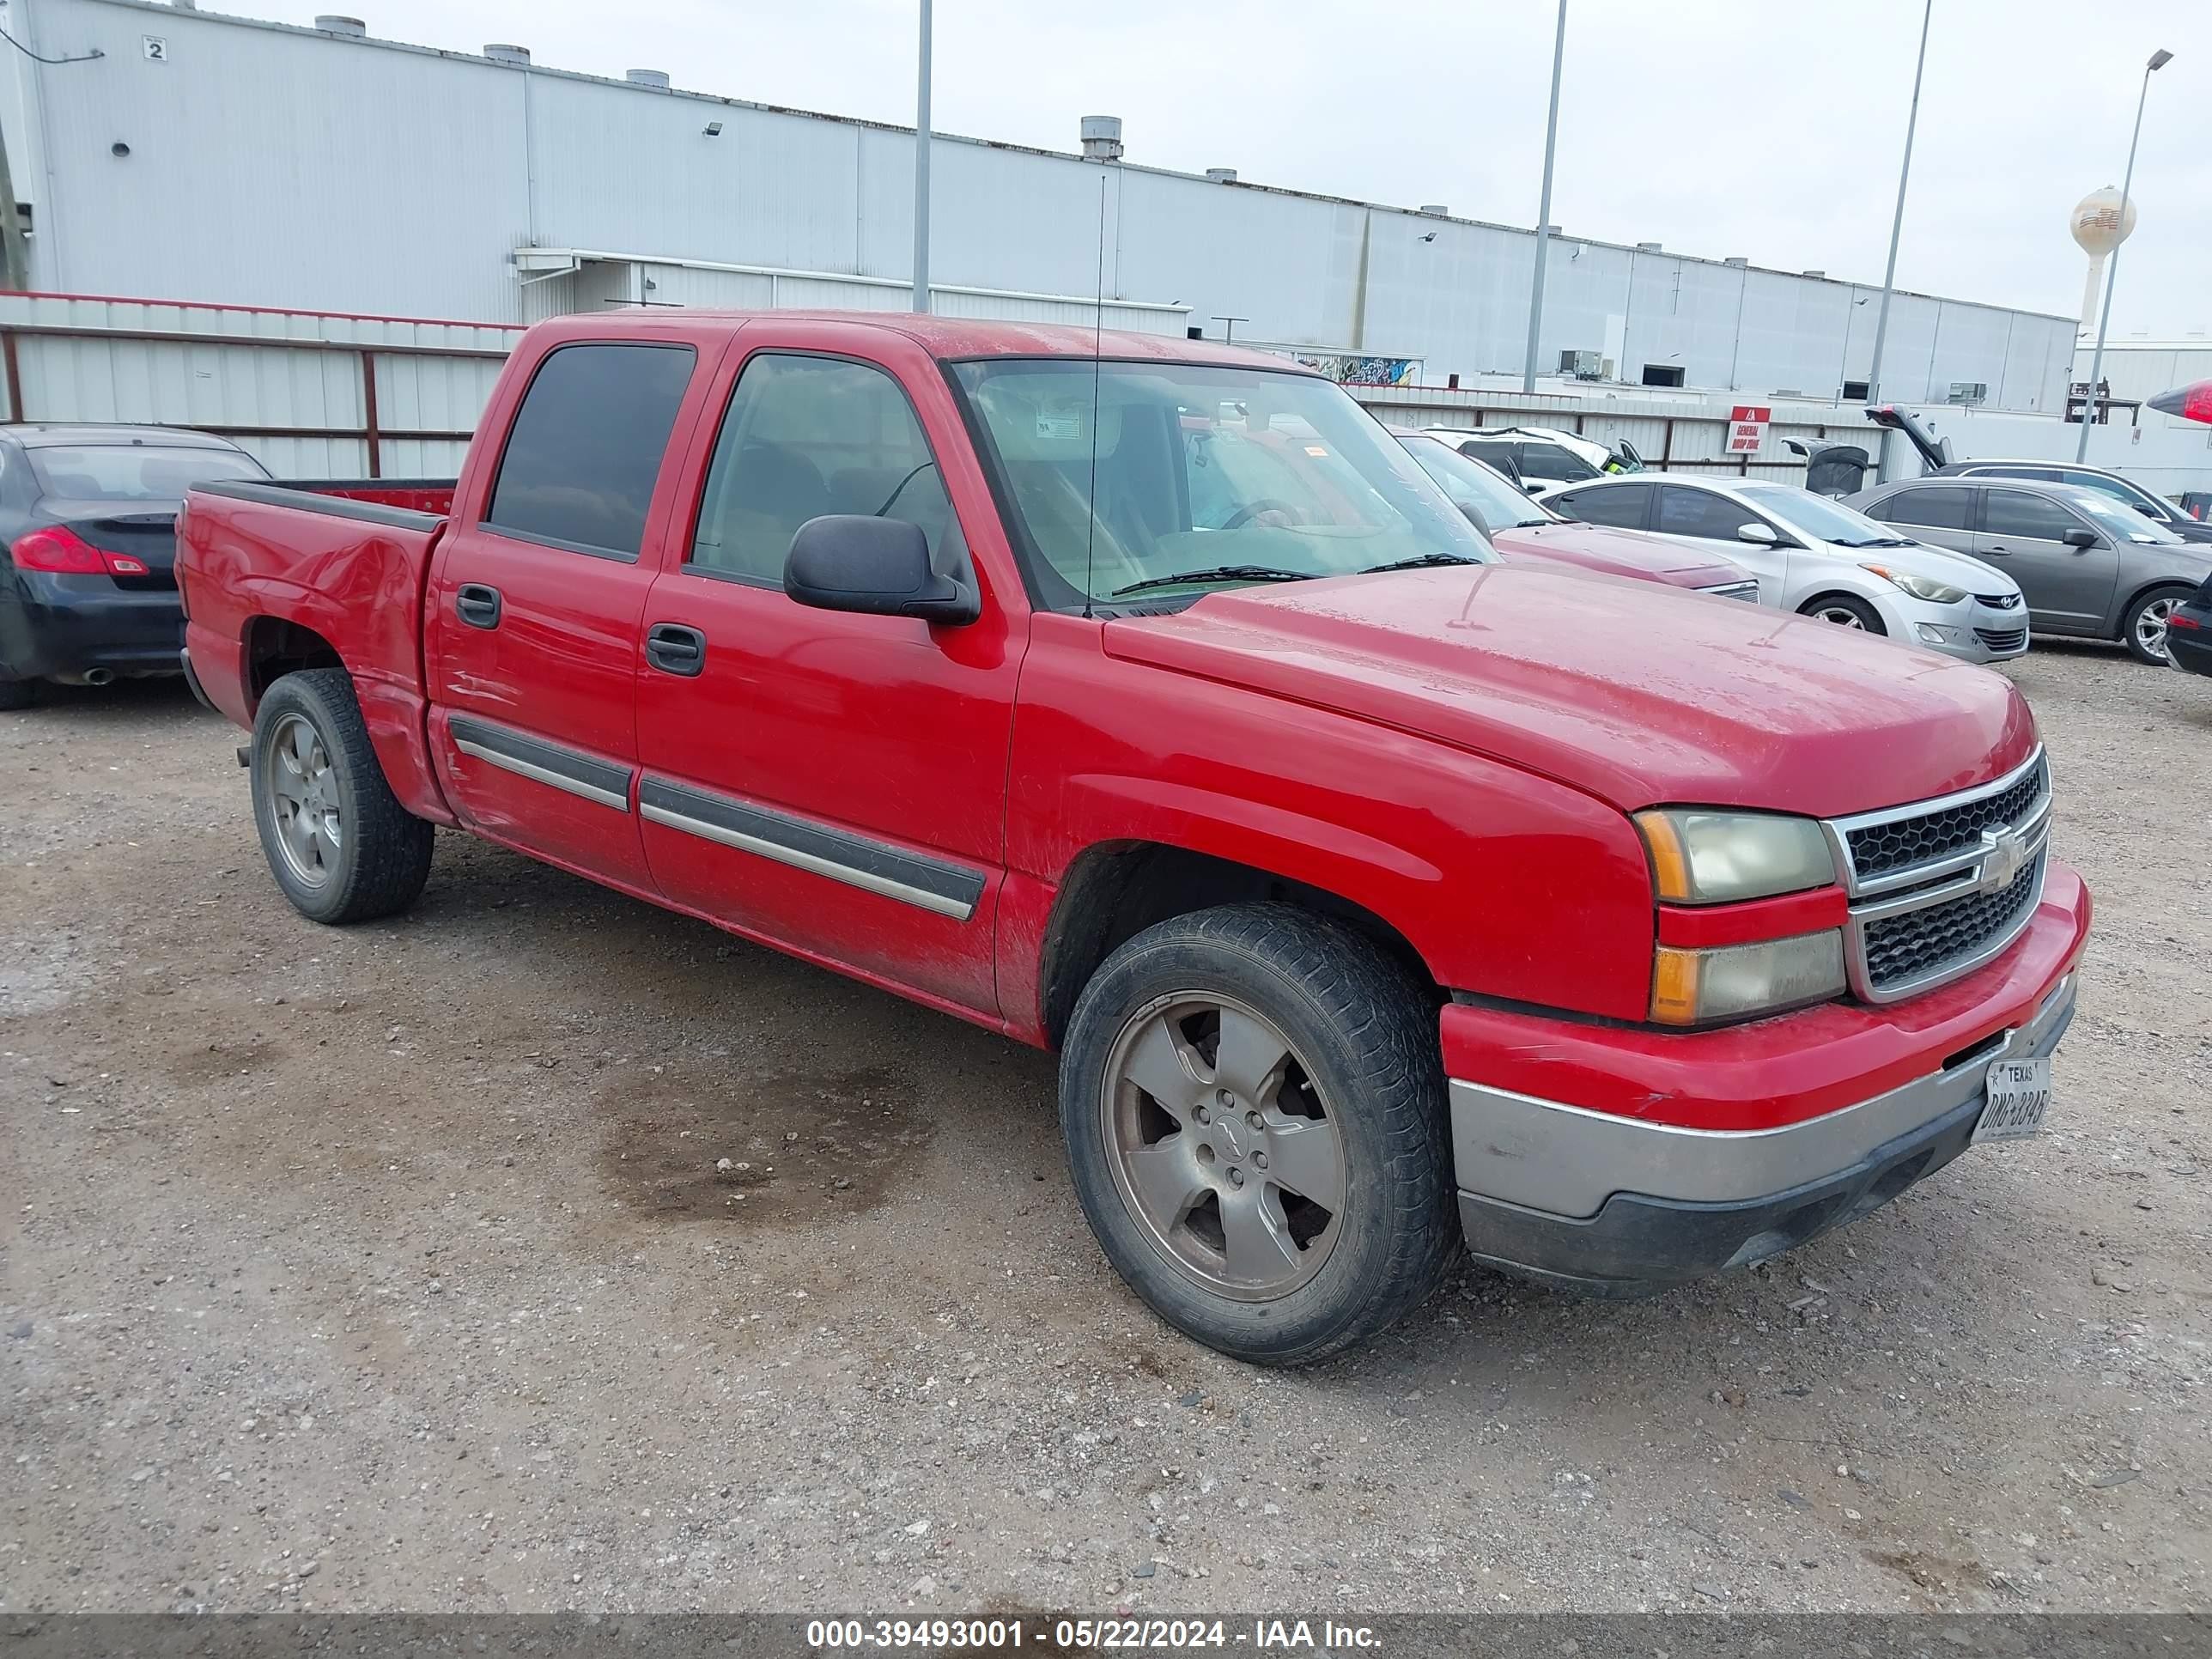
[{"xmin": 252, "ymin": 668, "xmax": 434, "ymax": 925}]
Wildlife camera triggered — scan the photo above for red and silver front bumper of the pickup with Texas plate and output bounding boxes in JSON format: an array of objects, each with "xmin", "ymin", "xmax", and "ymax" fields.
[{"xmin": 1447, "ymin": 865, "xmax": 2088, "ymax": 1294}]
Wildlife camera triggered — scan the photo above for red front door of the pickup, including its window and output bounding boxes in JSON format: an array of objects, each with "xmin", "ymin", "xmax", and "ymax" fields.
[{"xmin": 637, "ymin": 333, "xmax": 1026, "ymax": 1013}]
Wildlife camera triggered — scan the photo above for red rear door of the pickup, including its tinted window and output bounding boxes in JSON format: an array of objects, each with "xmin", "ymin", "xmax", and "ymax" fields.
[{"xmin": 427, "ymin": 330, "xmax": 712, "ymax": 891}]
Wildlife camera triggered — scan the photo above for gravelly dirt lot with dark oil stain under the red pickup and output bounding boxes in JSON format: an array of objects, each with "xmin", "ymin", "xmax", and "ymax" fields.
[{"xmin": 0, "ymin": 648, "xmax": 2212, "ymax": 1613}]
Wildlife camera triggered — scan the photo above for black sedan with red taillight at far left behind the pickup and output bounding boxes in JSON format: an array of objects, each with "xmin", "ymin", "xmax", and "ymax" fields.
[{"xmin": 0, "ymin": 425, "xmax": 268, "ymax": 708}]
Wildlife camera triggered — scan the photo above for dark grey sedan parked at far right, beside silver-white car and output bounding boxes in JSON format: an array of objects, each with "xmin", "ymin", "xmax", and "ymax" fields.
[{"xmin": 1851, "ymin": 477, "xmax": 2212, "ymax": 664}]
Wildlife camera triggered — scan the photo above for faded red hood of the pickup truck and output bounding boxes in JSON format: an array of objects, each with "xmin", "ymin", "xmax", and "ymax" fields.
[{"xmin": 1103, "ymin": 564, "xmax": 2035, "ymax": 817}]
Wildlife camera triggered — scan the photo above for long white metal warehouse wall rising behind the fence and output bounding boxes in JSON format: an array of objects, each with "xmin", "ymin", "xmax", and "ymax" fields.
[{"xmin": 0, "ymin": 0, "xmax": 2075, "ymax": 411}]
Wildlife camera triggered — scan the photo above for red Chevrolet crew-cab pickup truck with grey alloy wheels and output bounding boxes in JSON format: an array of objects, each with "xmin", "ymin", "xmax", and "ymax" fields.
[{"xmin": 179, "ymin": 310, "xmax": 2090, "ymax": 1363}]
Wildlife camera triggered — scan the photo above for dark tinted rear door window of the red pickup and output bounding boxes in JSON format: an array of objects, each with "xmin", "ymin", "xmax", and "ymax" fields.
[{"xmin": 484, "ymin": 345, "xmax": 696, "ymax": 560}]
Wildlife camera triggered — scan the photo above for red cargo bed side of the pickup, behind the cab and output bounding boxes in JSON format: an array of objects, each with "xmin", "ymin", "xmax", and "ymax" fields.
[{"xmin": 177, "ymin": 480, "xmax": 453, "ymax": 823}]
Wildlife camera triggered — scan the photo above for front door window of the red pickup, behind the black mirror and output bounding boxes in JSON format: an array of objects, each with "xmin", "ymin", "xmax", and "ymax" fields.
[{"xmin": 686, "ymin": 352, "xmax": 963, "ymax": 586}]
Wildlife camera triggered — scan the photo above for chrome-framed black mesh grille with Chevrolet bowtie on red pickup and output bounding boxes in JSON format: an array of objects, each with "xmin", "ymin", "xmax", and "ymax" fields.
[{"xmin": 1827, "ymin": 750, "xmax": 2051, "ymax": 1002}]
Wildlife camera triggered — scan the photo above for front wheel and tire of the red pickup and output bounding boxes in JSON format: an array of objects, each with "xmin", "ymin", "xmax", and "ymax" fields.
[{"xmin": 1060, "ymin": 905, "xmax": 1460, "ymax": 1364}]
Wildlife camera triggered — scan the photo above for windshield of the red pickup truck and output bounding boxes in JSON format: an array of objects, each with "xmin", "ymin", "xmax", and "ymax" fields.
[{"xmin": 956, "ymin": 358, "xmax": 1491, "ymax": 611}]
